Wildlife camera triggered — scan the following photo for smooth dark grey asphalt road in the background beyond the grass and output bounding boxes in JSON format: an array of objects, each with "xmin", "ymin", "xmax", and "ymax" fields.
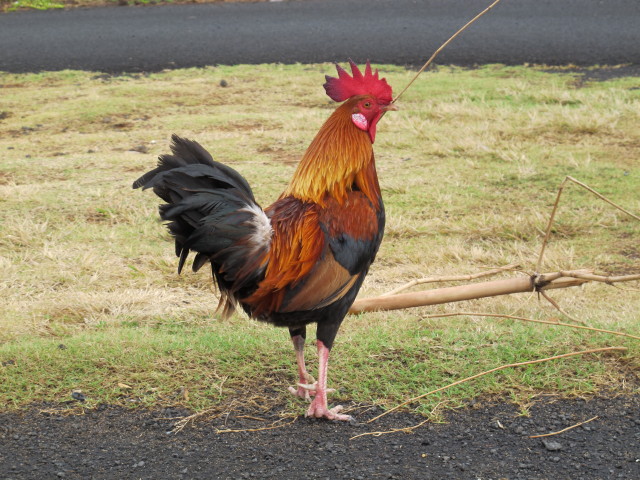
[{"xmin": 0, "ymin": 0, "xmax": 640, "ymax": 73}]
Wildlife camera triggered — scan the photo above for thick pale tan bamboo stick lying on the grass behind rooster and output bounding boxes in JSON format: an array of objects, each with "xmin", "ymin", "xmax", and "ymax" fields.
[{"xmin": 349, "ymin": 270, "xmax": 591, "ymax": 314}]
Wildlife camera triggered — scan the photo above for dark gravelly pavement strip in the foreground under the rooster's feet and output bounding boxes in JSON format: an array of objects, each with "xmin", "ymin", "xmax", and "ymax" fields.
[{"xmin": 0, "ymin": 394, "xmax": 640, "ymax": 480}]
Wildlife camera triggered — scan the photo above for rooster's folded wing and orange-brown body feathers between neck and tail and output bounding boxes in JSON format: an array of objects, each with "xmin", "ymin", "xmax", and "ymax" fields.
[{"xmin": 243, "ymin": 191, "xmax": 384, "ymax": 317}]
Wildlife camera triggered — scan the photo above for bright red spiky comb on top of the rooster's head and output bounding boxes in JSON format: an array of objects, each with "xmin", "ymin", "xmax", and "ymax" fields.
[{"xmin": 324, "ymin": 60, "xmax": 393, "ymax": 103}]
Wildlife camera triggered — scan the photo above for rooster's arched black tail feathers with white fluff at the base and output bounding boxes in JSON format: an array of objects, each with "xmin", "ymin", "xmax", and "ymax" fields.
[{"xmin": 133, "ymin": 135, "xmax": 270, "ymax": 312}]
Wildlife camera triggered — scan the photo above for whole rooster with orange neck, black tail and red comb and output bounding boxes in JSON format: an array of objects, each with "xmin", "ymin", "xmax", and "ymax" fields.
[{"xmin": 133, "ymin": 61, "xmax": 395, "ymax": 420}]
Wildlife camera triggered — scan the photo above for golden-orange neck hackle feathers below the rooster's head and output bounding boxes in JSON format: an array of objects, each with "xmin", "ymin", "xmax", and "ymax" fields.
[{"xmin": 282, "ymin": 98, "xmax": 380, "ymax": 207}]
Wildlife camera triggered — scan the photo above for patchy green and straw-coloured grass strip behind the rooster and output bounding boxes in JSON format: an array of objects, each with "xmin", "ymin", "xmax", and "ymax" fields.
[{"xmin": 0, "ymin": 65, "xmax": 640, "ymax": 420}]
